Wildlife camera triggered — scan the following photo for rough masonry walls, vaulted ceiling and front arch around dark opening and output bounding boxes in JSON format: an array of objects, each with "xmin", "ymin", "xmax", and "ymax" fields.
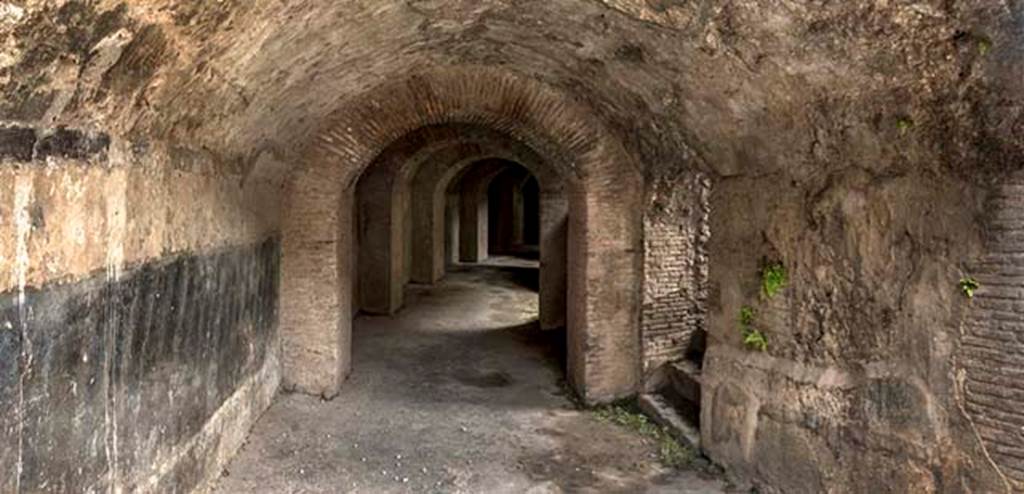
[{"xmin": 0, "ymin": 0, "xmax": 1024, "ymax": 493}]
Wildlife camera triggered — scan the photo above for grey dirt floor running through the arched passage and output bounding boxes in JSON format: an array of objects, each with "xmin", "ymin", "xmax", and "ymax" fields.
[{"xmin": 215, "ymin": 259, "xmax": 724, "ymax": 494}]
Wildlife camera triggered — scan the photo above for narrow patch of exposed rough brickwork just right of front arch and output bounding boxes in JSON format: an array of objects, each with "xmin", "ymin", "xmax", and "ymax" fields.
[{"xmin": 641, "ymin": 173, "xmax": 711, "ymax": 373}]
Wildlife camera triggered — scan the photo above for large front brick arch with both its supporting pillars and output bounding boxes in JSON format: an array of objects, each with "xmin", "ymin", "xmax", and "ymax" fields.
[{"xmin": 281, "ymin": 67, "xmax": 642, "ymax": 402}]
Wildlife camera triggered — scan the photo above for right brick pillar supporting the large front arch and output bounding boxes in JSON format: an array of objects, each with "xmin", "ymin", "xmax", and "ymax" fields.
[{"xmin": 566, "ymin": 173, "xmax": 642, "ymax": 403}]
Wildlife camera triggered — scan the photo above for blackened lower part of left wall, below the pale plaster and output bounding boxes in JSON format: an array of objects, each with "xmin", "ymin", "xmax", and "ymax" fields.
[{"xmin": 0, "ymin": 239, "xmax": 281, "ymax": 492}]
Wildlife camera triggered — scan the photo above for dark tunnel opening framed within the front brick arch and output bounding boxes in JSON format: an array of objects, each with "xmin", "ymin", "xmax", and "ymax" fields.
[{"xmin": 352, "ymin": 135, "xmax": 568, "ymax": 379}]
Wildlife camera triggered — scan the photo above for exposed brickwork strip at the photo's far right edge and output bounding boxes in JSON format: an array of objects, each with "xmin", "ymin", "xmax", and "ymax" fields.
[{"xmin": 961, "ymin": 173, "xmax": 1024, "ymax": 490}]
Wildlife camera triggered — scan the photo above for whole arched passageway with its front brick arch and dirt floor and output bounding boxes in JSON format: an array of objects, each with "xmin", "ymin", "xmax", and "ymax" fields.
[{"xmin": 211, "ymin": 71, "xmax": 719, "ymax": 492}]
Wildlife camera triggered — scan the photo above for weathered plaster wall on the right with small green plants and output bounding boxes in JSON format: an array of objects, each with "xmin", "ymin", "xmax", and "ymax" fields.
[{"xmin": 700, "ymin": 169, "xmax": 1013, "ymax": 493}]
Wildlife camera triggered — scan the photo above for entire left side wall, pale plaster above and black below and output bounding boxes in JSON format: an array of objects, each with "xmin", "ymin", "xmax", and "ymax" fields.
[{"xmin": 0, "ymin": 125, "xmax": 281, "ymax": 493}]
